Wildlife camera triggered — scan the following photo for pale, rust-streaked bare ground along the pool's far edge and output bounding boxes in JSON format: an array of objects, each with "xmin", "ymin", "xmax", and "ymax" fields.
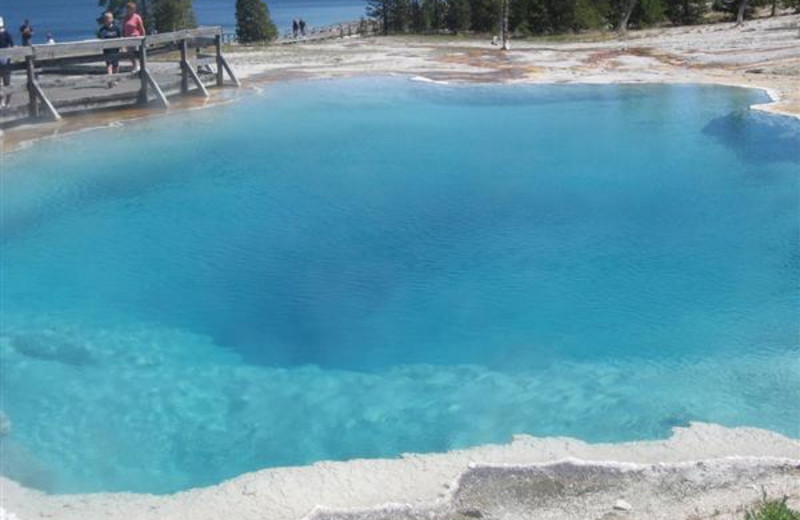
[{"xmin": 0, "ymin": 15, "xmax": 800, "ymax": 153}]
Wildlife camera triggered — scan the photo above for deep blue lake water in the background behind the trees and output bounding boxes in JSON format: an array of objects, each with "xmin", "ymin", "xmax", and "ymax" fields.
[{"xmin": 0, "ymin": 0, "xmax": 366, "ymax": 44}]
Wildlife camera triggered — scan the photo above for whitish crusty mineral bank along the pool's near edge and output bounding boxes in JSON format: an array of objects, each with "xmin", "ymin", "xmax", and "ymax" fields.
[{"xmin": 0, "ymin": 423, "xmax": 800, "ymax": 520}]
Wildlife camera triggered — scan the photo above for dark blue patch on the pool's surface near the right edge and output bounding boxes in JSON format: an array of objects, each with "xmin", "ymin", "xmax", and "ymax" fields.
[{"xmin": 703, "ymin": 110, "xmax": 800, "ymax": 164}]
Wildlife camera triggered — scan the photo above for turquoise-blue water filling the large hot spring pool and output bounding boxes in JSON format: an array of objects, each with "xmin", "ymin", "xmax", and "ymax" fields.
[{"xmin": 0, "ymin": 79, "xmax": 800, "ymax": 493}]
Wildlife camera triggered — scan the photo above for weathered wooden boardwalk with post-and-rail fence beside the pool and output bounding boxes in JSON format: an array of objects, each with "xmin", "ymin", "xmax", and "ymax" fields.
[{"xmin": 0, "ymin": 27, "xmax": 240, "ymax": 123}]
